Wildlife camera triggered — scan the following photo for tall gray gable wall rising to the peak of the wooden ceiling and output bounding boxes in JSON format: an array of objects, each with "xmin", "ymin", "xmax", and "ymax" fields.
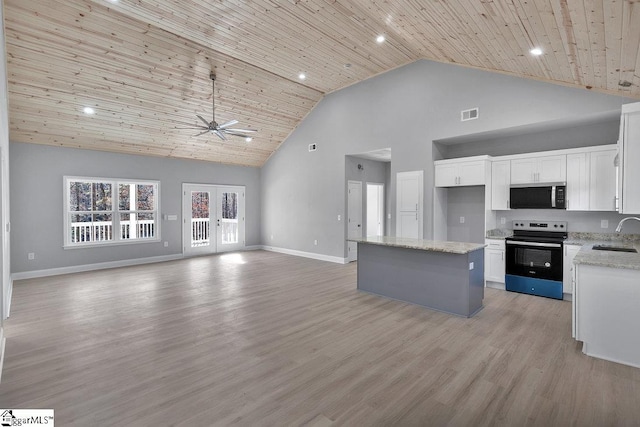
[{"xmin": 261, "ymin": 61, "xmax": 623, "ymax": 257}]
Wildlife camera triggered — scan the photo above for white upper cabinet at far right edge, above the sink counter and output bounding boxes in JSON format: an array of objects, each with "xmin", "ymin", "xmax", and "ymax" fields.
[{"xmin": 618, "ymin": 102, "xmax": 640, "ymax": 214}]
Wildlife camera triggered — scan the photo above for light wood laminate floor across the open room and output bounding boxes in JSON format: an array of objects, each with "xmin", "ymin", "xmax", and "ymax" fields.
[{"xmin": 0, "ymin": 251, "xmax": 640, "ymax": 426}]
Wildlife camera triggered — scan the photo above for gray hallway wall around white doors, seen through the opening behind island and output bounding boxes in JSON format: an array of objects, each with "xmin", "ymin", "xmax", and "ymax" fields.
[{"xmin": 345, "ymin": 156, "xmax": 391, "ymax": 236}]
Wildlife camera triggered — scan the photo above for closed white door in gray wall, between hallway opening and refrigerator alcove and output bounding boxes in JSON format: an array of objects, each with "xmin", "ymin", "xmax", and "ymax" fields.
[{"xmin": 396, "ymin": 171, "xmax": 423, "ymax": 239}]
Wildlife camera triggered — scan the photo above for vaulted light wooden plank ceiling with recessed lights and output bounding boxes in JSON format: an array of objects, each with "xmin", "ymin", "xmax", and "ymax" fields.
[{"xmin": 4, "ymin": 0, "xmax": 640, "ymax": 166}]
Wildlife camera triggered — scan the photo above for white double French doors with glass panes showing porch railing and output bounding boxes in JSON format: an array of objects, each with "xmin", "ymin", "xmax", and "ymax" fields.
[{"xmin": 182, "ymin": 184, "xmax": 245, "ymax": 256}]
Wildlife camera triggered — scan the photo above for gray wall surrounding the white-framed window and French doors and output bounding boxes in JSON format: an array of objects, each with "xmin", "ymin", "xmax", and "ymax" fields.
[{"xmin": 10, "ymin": 143, "xmax": 260, "ymax": 273}]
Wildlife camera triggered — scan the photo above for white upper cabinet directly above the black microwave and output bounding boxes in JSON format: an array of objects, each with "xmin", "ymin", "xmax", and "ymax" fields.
[{"xmin": 511, "ymin": 154, "xmax": 567, "ymax": 184}]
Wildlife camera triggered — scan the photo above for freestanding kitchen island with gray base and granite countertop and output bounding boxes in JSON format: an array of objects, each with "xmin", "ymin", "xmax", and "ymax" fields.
[{"xmin": 352, "ymin": 237, "xmax": 485, "ymax": 317}]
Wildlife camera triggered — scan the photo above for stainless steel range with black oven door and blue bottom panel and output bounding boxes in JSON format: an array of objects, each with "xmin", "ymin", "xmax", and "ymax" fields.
[{"xmin": 505, "ymin": 220, "xmax": 567, "ymax": 299}]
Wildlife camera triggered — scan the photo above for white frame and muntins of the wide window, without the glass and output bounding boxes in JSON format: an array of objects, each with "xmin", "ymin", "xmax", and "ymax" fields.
[{"xmin": 63, "ymin": 176, "xmax": 162, "ymax": 249}]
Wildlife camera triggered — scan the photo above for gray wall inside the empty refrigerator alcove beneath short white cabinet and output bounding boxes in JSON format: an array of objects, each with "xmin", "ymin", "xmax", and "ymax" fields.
[{"xmin": 447, "ymin": 186, "xmax": 485, "ymax": 243}]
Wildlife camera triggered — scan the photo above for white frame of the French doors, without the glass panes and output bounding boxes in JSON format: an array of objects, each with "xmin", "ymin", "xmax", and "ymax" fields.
[{"xmin": 181, "ymin": 182, "xmax": 246, "ymax": 257}]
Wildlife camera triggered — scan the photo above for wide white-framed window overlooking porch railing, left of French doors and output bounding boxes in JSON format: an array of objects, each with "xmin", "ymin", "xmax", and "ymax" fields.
[{"xmin": 64, "ymin": 177, "xmax": 160, "ymax": 247}]
